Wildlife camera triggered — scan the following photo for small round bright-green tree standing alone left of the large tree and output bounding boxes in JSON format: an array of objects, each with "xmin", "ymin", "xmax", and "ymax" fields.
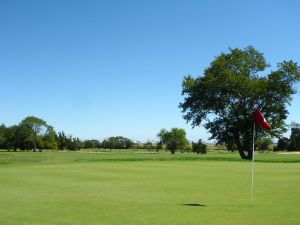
[{"xmin": 157, "ymin": 128, "xmax": 188, "ymax": 154}]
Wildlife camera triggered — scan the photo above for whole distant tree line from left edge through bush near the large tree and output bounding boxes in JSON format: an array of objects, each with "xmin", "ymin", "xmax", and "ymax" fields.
[{"xmin": 0, "ymin": 116, "xmax": 206, "ymax": 154}]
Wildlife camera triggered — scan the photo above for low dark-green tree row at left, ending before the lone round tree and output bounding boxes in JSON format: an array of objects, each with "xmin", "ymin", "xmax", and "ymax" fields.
[{"xmin": 0, "ymin": 116, "xmax": 134, "ymax": 151}]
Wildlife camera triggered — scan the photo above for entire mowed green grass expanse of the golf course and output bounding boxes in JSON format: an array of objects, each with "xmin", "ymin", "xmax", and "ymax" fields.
[{"xmin": 0, "ymin": 151, "xmax": 300, "ymax": 225}]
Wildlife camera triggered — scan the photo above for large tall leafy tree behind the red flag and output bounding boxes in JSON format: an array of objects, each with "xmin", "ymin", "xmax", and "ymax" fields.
[{"xmin": 179, "ymin": 46, "xmax": 300, "ymax": 159}]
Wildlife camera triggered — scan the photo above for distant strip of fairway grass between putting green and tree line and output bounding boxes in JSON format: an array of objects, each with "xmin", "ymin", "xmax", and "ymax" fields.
[{"xmin": 0, "ymin": 149, "xmax": 300, "ymax": 165}]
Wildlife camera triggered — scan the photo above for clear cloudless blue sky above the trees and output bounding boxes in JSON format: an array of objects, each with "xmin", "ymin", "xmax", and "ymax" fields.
[{"xmin": 0, "ymin": 0, "xmax": 300, "ymax": 141}]
